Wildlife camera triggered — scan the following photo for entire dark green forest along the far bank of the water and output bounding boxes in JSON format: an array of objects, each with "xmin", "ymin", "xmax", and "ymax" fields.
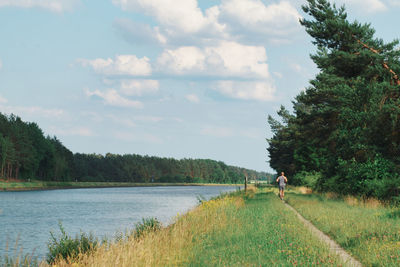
[{"xmin": 0, "ymin": 113, "xmax": 268, "ymax": 183}]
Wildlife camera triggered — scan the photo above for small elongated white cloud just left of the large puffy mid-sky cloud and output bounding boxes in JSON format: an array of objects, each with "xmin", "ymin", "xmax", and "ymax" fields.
[{"xmin": 78, "ymin": 55, "xmax": 152, "ymax": 76}]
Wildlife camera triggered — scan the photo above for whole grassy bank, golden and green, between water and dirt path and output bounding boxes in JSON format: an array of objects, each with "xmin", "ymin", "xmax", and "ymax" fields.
[{"xmin": 50, "ymin": 189, "xmax": 341, "ymax": 266}]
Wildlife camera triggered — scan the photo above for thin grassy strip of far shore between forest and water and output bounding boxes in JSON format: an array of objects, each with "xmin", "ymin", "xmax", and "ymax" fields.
[{"xmin": 0, "ymin": 180, "xmax": 243, "ymax": 192}]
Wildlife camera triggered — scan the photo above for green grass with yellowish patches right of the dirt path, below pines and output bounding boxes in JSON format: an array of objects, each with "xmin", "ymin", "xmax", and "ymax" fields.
[{"xmin": 287, "ymin": 193, "xmax": 400, "ymax": 266}]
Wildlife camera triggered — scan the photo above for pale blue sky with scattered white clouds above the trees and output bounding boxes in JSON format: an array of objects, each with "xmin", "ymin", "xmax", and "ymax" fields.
[{"xmin": 0, "ymin": 0, "xmax": 400, "ymax": 172}]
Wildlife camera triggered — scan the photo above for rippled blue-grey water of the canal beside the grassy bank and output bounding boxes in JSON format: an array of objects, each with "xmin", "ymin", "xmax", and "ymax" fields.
[{"xmin": 0, "ymin": 186, "xmax": 238, "ymax": 259}]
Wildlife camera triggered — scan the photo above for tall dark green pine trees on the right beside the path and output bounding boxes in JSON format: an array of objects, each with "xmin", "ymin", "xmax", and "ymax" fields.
[{"xmin": 267, "ymin": 0, "xmax": 400, "ymax": 200}]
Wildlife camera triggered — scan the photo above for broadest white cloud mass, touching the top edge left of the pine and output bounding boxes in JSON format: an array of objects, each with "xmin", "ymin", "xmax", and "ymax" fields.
[{"xmin": 113, "ymin": 0, "xmax": 300, "ymax": 45}]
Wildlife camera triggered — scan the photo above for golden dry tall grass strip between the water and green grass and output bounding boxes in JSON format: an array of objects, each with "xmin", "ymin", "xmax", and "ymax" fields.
[{"xmin": 50, "ymin": 196, "xmax": 244, "ymax": 267}]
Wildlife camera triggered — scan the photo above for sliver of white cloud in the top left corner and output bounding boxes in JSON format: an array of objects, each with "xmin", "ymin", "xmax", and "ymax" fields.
[{"xmin": 0, "ymin": 0, "xmax": 80, "ymax": 13}]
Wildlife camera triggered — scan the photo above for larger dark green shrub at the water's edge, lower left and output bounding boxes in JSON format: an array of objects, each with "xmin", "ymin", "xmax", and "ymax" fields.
[{"xmin": 47, "ymin": 222, "xmax": 99, "ymax": 264}]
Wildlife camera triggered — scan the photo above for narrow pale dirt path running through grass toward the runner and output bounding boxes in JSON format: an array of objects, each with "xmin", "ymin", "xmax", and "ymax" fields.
[{"xmin": 284, "ymin": 202, "xmax": 362, "ymax": 267}]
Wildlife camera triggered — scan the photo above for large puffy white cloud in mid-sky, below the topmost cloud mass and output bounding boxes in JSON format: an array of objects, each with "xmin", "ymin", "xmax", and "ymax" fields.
[{"xmin": 157, "ymin": 41, "xmax": 269, "ymax": 79}]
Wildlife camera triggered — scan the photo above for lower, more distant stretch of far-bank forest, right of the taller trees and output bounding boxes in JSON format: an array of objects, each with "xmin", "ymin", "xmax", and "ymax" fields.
[{"xmin": 74, "ymin": 154, "xmax": 268, "ymax": 183}]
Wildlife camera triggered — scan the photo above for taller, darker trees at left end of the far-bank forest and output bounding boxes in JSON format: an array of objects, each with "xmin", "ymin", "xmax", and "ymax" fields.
[{"xmin": 0, "ymin": 113, "xmax": 74, "ymax": 181}]
